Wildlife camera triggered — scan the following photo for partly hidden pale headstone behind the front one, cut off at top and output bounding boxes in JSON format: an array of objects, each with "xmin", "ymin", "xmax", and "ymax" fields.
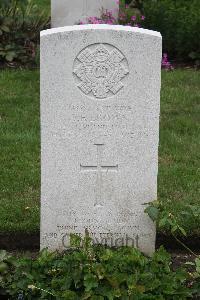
[{"xmin": 51, "ymin": 0, "xmax": 119, "ymax": 27}]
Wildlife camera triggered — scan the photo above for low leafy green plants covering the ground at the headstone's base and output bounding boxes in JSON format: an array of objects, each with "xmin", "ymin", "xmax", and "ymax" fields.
[{"xmin": 0, "ymin": 241, "xmax": 199, "ymax": 300}]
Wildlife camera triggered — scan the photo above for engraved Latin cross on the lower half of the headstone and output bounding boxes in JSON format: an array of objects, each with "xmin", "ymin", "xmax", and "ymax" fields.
[{"xmin": 80, "ymin": 144, "xmax": 118, "ymax": 206}]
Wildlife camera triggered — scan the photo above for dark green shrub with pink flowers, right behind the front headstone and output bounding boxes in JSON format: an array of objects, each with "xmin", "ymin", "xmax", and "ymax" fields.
[{"xmin": 143, "ymin": 0, "xmax": 200, "ymax": 62}]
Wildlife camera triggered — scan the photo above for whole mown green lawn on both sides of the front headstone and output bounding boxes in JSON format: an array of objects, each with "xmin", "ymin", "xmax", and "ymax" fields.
[{"xmin": 0, "ymin": 70, "xmax": 200, "ymax": 233}]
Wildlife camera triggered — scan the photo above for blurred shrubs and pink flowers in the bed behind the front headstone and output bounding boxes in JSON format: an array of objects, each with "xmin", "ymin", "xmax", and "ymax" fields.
[{"xmin": 0, "ymin": 0, "xmax": 200, "ymax": 66}]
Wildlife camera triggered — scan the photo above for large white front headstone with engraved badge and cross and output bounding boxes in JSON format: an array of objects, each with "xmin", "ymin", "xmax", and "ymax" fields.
[{"xmin": 41, "ymin": 25, "xmax": 161, "ymax": 254}]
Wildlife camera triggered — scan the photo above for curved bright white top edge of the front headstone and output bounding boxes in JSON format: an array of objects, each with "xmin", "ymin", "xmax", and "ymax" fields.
[{"xmin": 40, "ymin": 24, "xmax": 162, "ymax": 38}]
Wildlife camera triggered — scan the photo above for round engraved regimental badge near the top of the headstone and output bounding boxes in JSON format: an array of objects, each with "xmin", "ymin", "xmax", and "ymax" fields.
[{"xmin": 73, "ymin": 44, "xmax": 129, "ymax": 99}]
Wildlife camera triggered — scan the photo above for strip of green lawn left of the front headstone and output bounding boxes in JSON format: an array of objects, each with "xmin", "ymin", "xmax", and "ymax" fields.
[{"xmin": 0, "ymin": 71, "xmax": 40, "ymax": 232}]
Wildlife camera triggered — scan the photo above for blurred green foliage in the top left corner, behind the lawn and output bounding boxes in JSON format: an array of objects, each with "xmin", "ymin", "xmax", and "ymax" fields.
[{"xmin": 0, "ymin": 0, "xmax": 48, "ymax": 63}]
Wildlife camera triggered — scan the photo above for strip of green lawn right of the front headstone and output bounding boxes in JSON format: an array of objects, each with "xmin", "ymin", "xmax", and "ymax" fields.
[{"xmin": 158, "ymin": 70, "xmax": 200, "ymax": 234}]
